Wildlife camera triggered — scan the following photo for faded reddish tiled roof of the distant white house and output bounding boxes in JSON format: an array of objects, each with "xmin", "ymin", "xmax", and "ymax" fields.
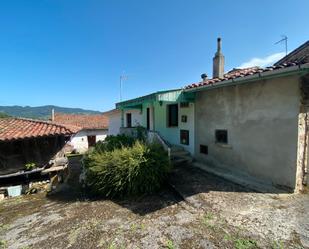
[{"xmin": 53, "ymin": 113, "xmax": 108, "ymax": 129}]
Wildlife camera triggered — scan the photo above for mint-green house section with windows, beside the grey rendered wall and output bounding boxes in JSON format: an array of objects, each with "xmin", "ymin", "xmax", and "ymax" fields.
[{"xmin": 116, "ymin": 89, "xmax": 195, "ymax": 154}]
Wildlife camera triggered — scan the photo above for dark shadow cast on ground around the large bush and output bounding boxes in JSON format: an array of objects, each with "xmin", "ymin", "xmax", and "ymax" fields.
[{"xmin": 47, "ymin": 155, "xmax": 252, "ymax": 215}]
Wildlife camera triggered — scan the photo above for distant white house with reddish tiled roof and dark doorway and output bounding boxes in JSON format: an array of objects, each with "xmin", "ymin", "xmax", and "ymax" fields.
[{"xmin": 52, "ymin": 113, "xmax": 108, "ymax": 153}]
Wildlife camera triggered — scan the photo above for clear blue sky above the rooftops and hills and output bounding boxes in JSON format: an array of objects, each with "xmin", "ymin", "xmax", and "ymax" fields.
[{"xmin": 0, "ymin": 0, "xmax": 309, "ymax": 111}]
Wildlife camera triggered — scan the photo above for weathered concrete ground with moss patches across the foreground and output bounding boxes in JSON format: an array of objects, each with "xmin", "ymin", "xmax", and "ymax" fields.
[{"xmin": 0, "ymin": 162, "xmax": 309, "ymax": 249}]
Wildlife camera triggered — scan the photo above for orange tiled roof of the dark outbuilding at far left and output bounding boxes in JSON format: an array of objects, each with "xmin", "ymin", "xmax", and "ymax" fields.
[{"xmin": 0, "ymin": 118, "xmax": 74, "ymax": 141}]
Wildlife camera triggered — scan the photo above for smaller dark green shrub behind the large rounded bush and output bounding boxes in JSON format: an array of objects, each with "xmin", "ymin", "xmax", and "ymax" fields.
[{"xmin": 94, "ymin": 134, "xmax": 135, "ymax": 152}]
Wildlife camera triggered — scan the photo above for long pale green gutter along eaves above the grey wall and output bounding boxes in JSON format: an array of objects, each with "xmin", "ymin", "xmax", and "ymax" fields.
[{"xmin": 184, "ymin": 63, "xmax": 309, "ymax": 92}]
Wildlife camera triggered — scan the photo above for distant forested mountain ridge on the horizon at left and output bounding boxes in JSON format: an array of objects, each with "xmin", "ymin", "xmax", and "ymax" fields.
[{"xmin": 0, "ymin": 105, "xmax": 101, "ymax": 120}]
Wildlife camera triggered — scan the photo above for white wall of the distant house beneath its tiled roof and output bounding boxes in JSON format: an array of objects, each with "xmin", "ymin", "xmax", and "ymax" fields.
[{"xmin": 69, "ymin": 129, "xmax": 108, "ymax": 153}]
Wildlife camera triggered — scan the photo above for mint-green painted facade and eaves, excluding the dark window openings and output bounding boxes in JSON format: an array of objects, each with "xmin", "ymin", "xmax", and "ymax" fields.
[{"xmin": 116, "ymin": 89, "xmax": 195, "ymax": 155}]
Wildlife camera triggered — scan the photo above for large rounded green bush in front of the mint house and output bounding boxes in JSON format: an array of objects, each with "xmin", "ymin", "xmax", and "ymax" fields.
[{"xmin": 83, "ymin": 141, "xmax": 170, "ymax": 197}]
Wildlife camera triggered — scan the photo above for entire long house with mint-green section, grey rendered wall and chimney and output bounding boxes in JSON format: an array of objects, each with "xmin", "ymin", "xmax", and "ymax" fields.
[{"xmin": 116, "ymin": 39, "xmax": 309, "ymax": 192}]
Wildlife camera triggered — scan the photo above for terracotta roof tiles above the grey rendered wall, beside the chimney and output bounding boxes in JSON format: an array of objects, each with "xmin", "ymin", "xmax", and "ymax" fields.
[{"xmin": 185, "ymin": 61, "xmax": 303, "ymax": 89}]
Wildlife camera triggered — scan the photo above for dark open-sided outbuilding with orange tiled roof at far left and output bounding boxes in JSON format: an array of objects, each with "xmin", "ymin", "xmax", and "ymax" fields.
[{"xmin": 0, "ymin": 118, "xmax": 74, "ymax": 179}]
